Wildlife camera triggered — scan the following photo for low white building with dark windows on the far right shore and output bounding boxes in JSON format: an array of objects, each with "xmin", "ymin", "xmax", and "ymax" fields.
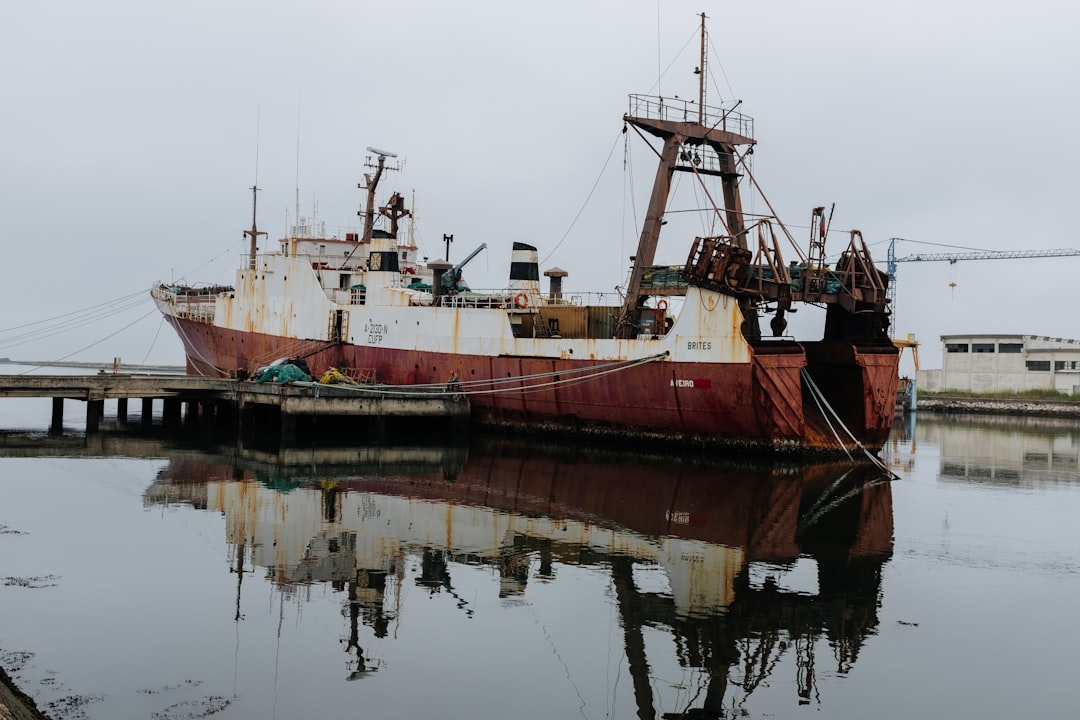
[{"xmin": 917, "ymin": 335, "xmax": 1080, "ymax": 395}]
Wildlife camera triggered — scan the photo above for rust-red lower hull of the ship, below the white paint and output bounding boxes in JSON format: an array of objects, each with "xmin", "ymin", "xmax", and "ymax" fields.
[{"xmin": 167, "ymin": 316, "xmax": 897, "ymax": 452}]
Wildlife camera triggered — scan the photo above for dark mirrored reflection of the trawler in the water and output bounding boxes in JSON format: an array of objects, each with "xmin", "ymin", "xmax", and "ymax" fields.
[{"xmin": 144, "ymin": 445, "xmax": 893, "ymax": 718}]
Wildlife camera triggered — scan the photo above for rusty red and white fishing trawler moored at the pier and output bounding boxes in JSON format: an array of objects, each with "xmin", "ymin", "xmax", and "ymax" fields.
[{"xmin": 151, "ymin": 19, "xmax": 899, "ymax": 454}]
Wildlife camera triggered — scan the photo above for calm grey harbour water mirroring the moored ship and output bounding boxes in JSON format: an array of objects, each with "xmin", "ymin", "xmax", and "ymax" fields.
[{"xmin": 0, "ymin": 382, "xmax": 1080, "ymax": 719}]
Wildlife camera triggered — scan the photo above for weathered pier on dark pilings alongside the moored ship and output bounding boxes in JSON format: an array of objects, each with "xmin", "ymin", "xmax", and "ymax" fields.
[{"xmin": 0, "ymin": 372, "xmax": 470, "ymax": 444}]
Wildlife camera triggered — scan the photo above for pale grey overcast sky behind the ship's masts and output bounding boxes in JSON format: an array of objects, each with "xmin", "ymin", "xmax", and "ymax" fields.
[{"xmin": 0, "ymin": 0, "xmax": 1080, "ymax": 367}]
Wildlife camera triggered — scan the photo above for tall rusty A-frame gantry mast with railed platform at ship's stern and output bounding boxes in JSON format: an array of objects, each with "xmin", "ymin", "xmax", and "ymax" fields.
[{"xmin": 616, "ymin": 13, "xmax": 755, "ymax": 338}]
